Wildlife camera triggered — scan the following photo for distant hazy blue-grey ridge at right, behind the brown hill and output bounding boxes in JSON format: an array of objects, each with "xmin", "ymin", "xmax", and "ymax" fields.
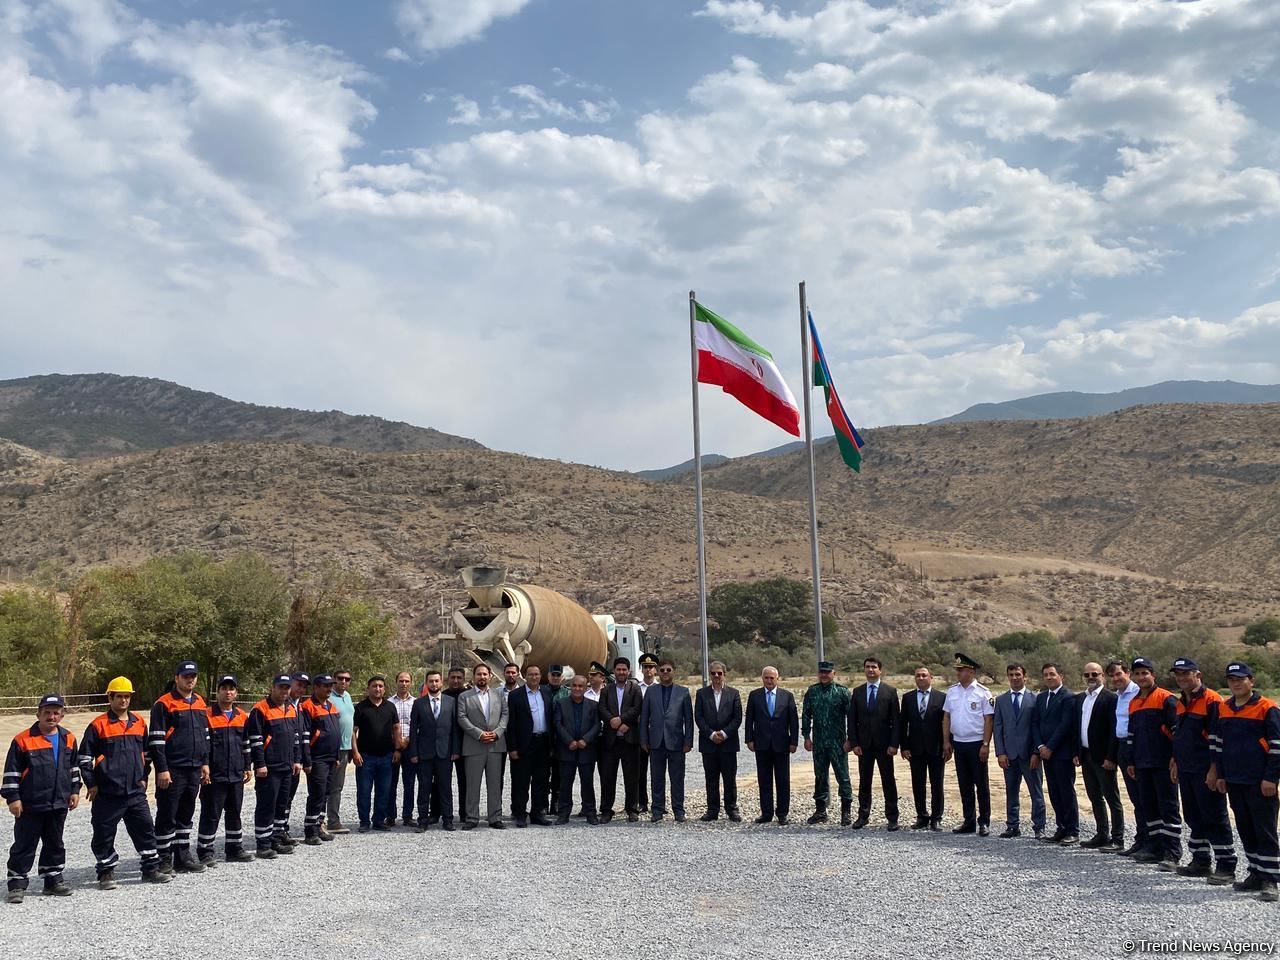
[{"xmin": 934, "ymin": 380, "xmax": 1280, "ymax": 424}]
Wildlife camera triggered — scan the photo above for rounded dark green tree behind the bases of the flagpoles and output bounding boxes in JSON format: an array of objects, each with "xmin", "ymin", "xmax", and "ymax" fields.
[{"xmin": 707, "ymin": 577, "xmax": 840, "ymax": 653}]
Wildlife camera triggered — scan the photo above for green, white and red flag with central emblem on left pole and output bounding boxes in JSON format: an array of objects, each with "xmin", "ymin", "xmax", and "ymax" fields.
[{"xmin": 694, "ymin": 303, "xmax": 800, "ymax": 436}]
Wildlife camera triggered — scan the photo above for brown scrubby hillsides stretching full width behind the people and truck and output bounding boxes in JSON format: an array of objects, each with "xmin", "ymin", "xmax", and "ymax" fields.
[{"xmin": 0, "ymin": 406, "xmax": 1280, "ymax": 660}]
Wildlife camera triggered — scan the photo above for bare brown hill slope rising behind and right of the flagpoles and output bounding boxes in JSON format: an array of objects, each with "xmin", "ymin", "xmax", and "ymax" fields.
[{"xmin": 681, "ymin": 404, "xmax": 1280, "ymax": 589}]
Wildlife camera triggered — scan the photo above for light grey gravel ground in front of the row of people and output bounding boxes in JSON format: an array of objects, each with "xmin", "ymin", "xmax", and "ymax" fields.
[{"xmin": 0, "ymin": 753, "xmax": 1280, "ymax": 960}]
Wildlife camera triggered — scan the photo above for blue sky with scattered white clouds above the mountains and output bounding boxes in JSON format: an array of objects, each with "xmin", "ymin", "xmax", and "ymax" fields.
[{"xmin": 0, "ymin": 0, "xmax": 1280, "ymax": 468}]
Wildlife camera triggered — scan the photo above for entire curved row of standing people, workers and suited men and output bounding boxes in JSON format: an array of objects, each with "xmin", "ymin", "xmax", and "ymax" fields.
[{"xmin": 0, "ymin": 654, "xmax": 1280, "ymax": 902}]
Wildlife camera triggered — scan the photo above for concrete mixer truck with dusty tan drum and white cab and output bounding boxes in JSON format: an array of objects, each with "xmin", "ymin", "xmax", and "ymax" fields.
[{"xmin": 440, "ymin": 567, "xmax": 657, "ymax": 676}]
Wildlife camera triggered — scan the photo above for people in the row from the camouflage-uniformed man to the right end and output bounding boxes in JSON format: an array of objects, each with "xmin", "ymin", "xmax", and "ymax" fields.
[{"xmin": 801, "ymin": 654, "xmax": 1280, "ymax": 902}]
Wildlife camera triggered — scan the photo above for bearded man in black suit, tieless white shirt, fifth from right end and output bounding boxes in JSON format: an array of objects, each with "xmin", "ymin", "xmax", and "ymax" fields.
[{"xmin": 1075, "ymin": 663, "xmax": 1124, "ymax": 852}]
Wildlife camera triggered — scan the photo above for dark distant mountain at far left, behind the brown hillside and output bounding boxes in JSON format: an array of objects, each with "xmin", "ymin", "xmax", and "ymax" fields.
[{"xmin": 0, "ymin": 374, "xmax": 480, "ymax": 457}]
